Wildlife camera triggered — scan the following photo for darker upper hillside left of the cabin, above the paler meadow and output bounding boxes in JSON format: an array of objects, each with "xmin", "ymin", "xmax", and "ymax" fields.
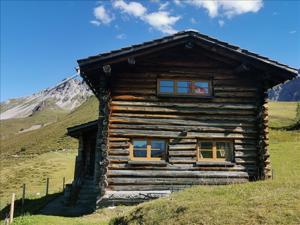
[{"xmin": 1, "ymin": 96, "xmax": 98, "ymax": 158}]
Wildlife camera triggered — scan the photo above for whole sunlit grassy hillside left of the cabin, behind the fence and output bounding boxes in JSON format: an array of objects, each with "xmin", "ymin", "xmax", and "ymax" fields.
[{"xmin": 0, "ymin": 97, "xmax": 98, "ymax": 209}]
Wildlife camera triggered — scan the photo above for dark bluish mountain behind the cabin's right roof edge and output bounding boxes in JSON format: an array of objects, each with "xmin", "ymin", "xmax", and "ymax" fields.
[{"xmin": 268, "ymin": 77, "xmax": 300, "ymax": 101}]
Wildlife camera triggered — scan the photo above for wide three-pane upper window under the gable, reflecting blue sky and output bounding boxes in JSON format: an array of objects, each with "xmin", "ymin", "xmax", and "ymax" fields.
[{"xmin": 157, "ymin": 80, "xmax": 211, "ymax": 96}]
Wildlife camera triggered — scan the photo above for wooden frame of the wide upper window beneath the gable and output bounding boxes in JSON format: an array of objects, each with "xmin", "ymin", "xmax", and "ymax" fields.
[{"xmin": 156, "ymin": 79, "xmax": 213, "ymax": 98}]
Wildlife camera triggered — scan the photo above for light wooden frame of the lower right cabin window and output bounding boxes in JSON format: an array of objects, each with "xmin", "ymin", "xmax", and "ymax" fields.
[{"xmin": 197, "ymin": 139, "xmax": 234, "ymax": 162}]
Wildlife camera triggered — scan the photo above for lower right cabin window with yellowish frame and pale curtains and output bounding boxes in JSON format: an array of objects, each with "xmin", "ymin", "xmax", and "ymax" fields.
[{"xmin": 197, "ymin": 140, "xmax": 233, "ymax": 161}]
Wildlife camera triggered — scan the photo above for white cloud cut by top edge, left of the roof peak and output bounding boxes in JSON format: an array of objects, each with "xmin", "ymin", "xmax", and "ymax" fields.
[{"xmin": 113, "ymin": 0, "xmax": 147, "ymax": 17}]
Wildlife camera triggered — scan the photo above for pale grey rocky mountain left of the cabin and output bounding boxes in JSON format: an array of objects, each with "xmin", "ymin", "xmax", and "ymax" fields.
[{"xmin": 0, "ymin": 78, "xmax": 92, "ymax": 120}]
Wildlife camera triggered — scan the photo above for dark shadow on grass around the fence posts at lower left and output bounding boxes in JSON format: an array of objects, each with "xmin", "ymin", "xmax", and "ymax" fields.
[{"xmin": 0, "ymin": 192, "xmax": 62, "ymax": 220}]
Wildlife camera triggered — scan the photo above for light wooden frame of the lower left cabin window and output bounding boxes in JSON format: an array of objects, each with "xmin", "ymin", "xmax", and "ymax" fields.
[{"xmin": 129, "ymin": 138, "xmax": 168, "ymax": 161}]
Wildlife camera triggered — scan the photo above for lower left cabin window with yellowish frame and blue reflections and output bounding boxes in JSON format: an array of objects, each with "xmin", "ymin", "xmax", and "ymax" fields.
[{"xmin": 130, "ymin": 138, "xmax": 166, "ymax": 160}]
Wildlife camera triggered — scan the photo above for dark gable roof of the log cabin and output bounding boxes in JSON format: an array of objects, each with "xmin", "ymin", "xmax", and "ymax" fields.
[{"xmin": 77, "ymin": 30, "xmax": 298, "ymax": 94}]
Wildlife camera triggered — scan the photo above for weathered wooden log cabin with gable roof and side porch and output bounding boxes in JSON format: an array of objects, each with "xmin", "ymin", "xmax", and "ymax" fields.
[{"xmin": 68, "ymin": 31, "xmax": 298, "ymax": 208}]
